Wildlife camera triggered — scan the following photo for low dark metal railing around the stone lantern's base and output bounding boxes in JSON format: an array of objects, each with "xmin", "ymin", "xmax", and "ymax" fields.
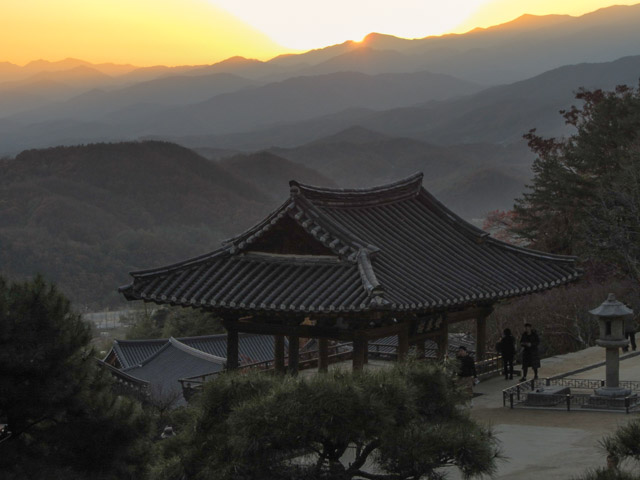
[{"xmin": 502, "ymin": 378, "xmax": 640, "ymax": 413}]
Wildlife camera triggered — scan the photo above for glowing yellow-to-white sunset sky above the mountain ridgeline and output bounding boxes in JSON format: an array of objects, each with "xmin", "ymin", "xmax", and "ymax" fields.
[{"xmin": 0, "ymin": 0, "xmax": 638, "ymax": 66}]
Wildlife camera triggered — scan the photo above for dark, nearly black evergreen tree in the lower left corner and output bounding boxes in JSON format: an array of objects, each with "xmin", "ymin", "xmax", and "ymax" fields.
[{"xmin": 0, "ymin": 277, "xmax": 149, "ymax": 480}]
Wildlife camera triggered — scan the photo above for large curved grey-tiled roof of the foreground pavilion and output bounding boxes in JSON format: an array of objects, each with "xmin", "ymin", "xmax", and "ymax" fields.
[{"xmin": 121, "ymin": 174, "xmax": 579, "ymax": 313}]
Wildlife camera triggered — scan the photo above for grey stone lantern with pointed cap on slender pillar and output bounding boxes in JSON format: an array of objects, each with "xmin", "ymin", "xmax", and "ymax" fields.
[{"xmin": 589, "ymin": 293, "xmax": 633, "ymax": 397}]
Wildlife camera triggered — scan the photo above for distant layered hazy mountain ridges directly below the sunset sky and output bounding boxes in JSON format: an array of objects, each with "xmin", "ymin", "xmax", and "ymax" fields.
[{"xmin": 0, "ymin": 4, "xmax": 640, "ymax": 154}]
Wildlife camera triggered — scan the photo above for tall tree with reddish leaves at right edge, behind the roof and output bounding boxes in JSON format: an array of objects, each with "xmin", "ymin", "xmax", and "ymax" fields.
[{"xmin": 513, "ymin": 82, "xmax": 640, "ymax": 278}]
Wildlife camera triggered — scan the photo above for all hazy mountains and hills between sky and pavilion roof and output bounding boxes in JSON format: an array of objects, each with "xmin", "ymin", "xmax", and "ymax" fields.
[{"xmin": 0, "ymin": 5, "xmax": 640, "ymax": 306}]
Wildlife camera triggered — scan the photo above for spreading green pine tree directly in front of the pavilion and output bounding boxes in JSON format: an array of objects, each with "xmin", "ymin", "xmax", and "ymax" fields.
[{"xmin": 158, "ymin": 362, "xmax": 498, "ymax": 480}]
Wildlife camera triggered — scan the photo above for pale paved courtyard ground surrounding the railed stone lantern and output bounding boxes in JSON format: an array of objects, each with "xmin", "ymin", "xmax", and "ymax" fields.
[{"xmin": 470, "ymin": 347, "xmax": 640, "ymax": 480}]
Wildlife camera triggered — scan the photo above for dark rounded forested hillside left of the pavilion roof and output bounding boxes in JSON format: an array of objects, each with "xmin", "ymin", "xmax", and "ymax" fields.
[{"xmin": 0, "ymin": 142, "xmax": 276, "ymax": 307}]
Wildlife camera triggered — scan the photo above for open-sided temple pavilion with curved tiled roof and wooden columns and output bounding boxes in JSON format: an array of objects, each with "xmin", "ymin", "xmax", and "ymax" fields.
[{"xmin": 120, "ymin": 174, "xmax": 580, "ymax": 373}]
